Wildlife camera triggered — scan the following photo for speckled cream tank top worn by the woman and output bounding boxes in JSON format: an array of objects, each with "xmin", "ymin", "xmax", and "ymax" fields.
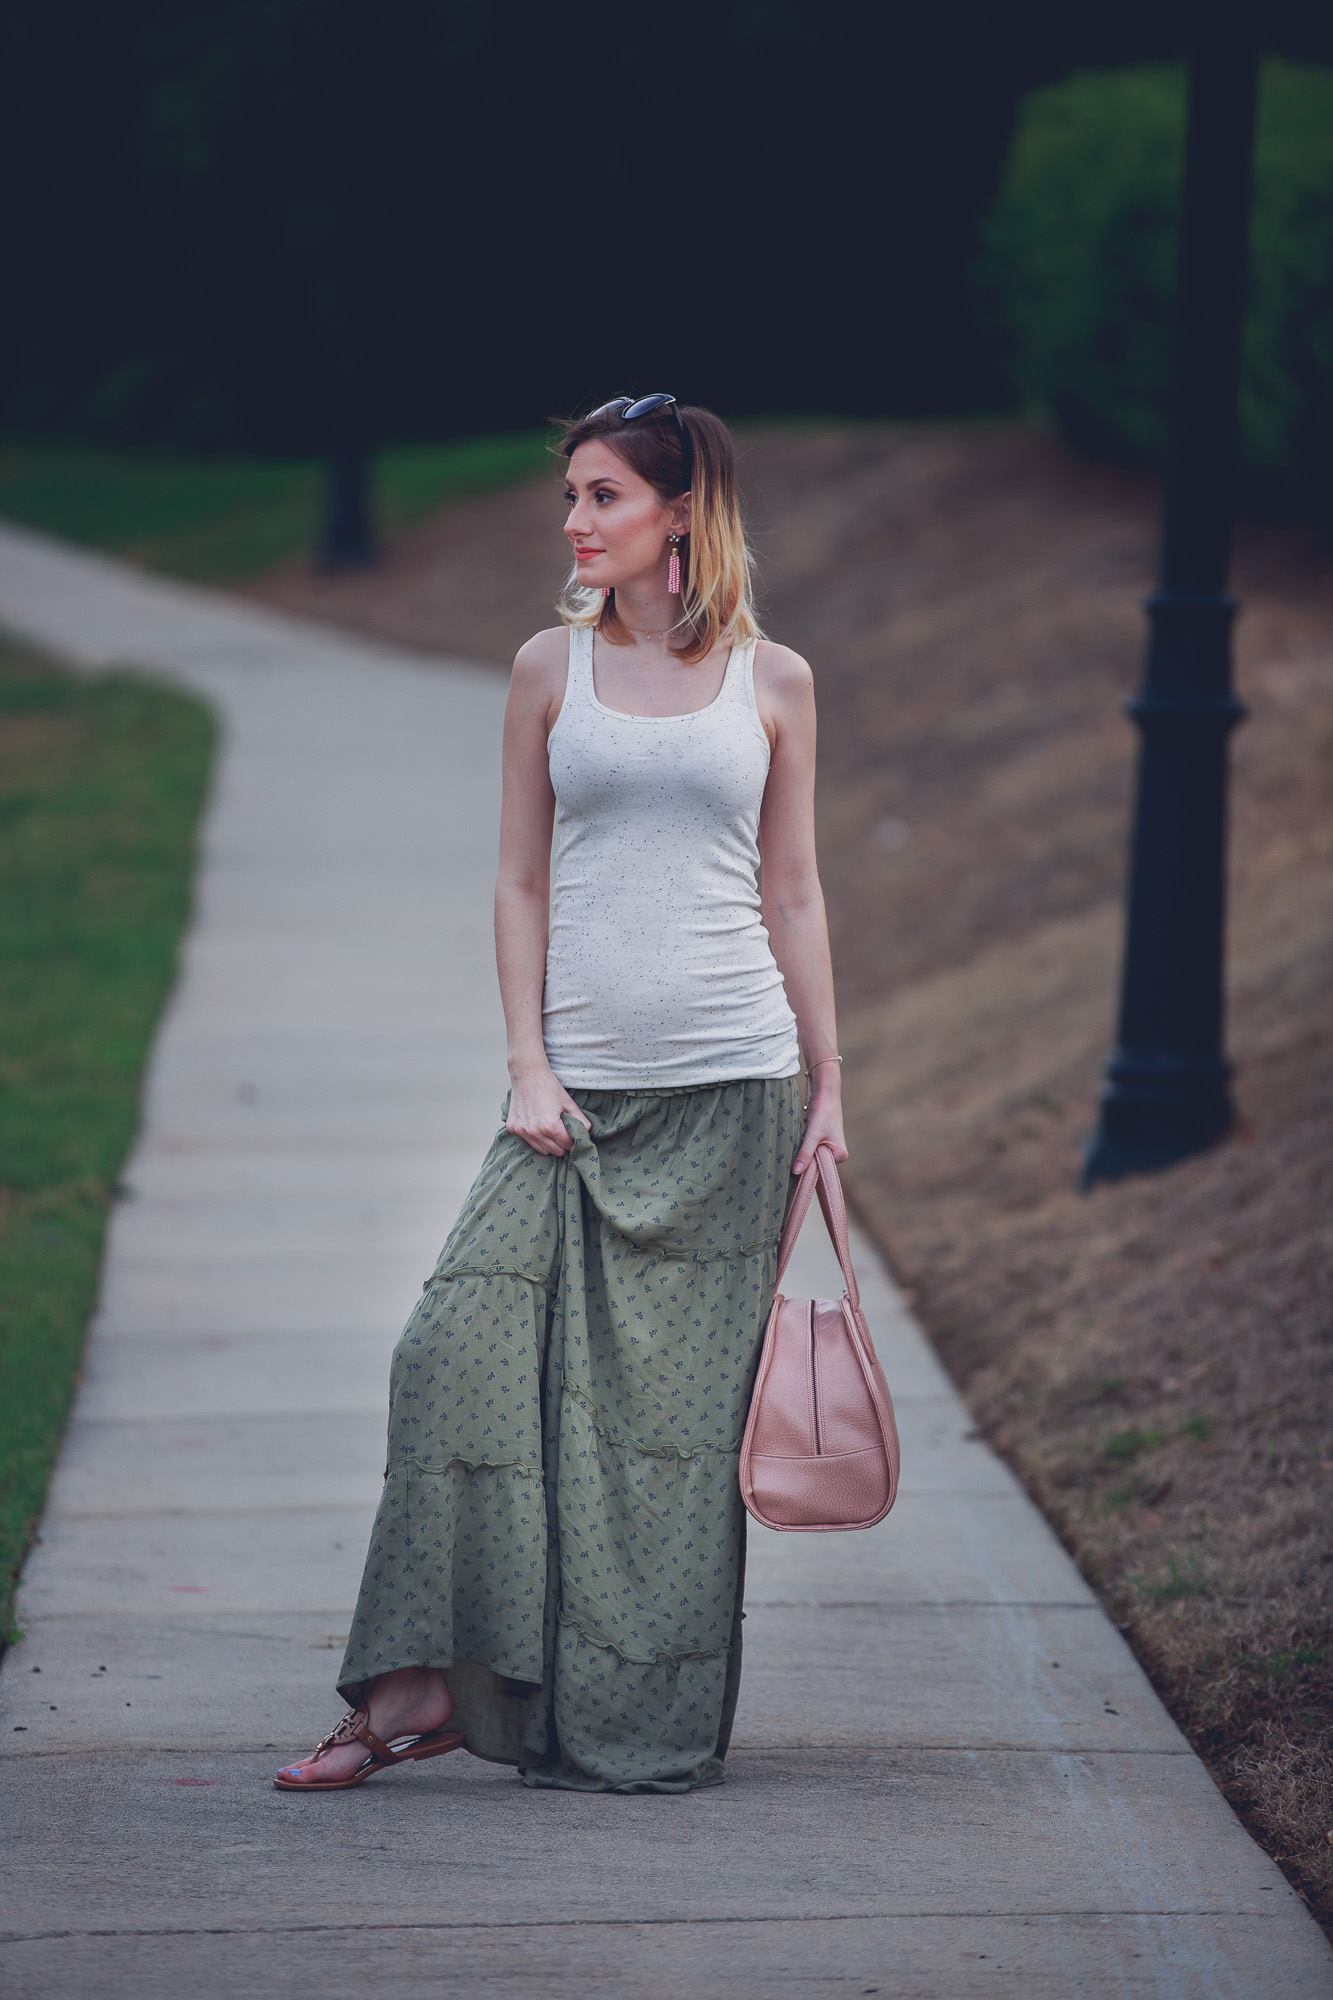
[{"xmin": 542, "ymin": 628, "xmax": 801, "ymax": 1090}]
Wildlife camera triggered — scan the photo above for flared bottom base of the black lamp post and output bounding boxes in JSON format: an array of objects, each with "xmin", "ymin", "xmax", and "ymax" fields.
[{"xmin": 1079, "ymin": 1052, "xmax": 1235, "ymax": 1194}]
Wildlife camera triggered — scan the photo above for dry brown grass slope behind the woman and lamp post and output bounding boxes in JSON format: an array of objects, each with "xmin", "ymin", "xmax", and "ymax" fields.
[{"xmin": 249, "ymin": 426, "xmax": 1333, "ymax": 1922}]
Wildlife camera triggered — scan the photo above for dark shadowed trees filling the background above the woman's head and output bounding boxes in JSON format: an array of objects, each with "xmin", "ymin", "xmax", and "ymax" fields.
[{"xmin": 10, "ymin": 0, "xmax": 1333, "ymax": 454}]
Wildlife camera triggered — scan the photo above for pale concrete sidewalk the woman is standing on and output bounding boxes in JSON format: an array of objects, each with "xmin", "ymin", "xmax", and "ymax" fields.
[{"xmin": 0, "ymin": 530, "xmax": 1333, "ymax": 2000}]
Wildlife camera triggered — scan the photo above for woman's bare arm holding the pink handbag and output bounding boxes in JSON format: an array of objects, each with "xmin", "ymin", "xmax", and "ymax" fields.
[{"xmin": 755, "ymin": 642, "xmax": 847, "ymax": 1174}]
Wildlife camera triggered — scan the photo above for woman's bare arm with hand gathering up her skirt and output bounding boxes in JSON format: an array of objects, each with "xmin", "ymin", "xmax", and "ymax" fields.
[{"xmin": 494, "ymin": 632, "xmax": 588, "ymax": 1154}]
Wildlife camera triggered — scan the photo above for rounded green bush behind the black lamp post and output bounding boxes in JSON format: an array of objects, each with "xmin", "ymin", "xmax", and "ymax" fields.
[{"xmin": 981, "ymin": 60, "xmax": 1333, "ymax": 506}]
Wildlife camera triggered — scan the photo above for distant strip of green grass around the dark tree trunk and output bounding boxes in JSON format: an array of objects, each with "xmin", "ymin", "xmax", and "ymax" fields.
[{"xmin": 0, "ymin": 430, "xmax": 550, "ymax": 584}]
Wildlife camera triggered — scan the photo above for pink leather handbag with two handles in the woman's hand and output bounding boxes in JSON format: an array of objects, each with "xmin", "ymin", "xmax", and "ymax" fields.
[{"xmin": 741, "ymin": 1146, "xmax": 899, "ymax": 1534}]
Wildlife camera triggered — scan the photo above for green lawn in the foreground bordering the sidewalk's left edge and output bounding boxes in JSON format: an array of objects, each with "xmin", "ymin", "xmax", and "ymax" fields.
[{"xmin": 0, "ymin": 642, "xmax": 214, "ymax": 1638}]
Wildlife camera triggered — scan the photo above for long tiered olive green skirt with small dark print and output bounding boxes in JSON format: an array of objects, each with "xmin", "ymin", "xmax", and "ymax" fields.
[{"xmin": 338, "ymin": 1076, "xmax": 803, "ymax": 1792}]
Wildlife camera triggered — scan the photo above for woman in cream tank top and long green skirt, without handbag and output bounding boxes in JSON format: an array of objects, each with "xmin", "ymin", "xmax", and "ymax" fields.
[{"xmin": 276, "ymin": 396, "xmax": 847, "ymax": 1792}]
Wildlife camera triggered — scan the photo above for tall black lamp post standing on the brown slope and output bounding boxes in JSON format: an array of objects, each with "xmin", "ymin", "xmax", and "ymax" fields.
[{"xmin": 1083, "ymin": 0, "xmax": 1259, "ymax": 1188}]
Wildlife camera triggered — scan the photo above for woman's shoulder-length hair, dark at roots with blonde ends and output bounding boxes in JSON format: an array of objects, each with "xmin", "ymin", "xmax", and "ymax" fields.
[{"xmin": 556, "ymin": 404, "xmax": 763, "ymax": 666}]
